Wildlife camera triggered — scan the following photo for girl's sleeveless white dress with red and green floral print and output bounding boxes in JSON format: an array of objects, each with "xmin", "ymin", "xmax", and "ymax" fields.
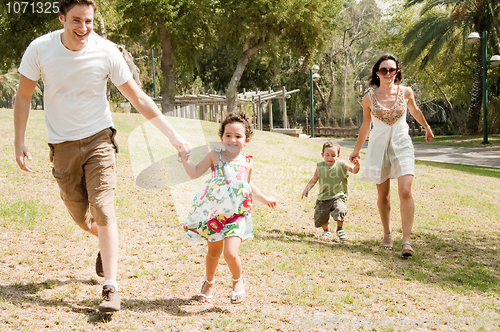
[{"xmin": 182, "ymin": 155, "xmax": 253, "ymax": 242}]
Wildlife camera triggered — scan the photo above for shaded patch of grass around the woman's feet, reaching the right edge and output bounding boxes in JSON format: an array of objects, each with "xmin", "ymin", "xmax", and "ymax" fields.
[{"xmin": 256, "ymin": 229, "xmax": 500, "ymax": 294}]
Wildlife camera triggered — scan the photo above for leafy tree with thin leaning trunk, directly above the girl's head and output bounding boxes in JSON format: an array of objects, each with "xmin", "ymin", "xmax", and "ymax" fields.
[{"xmin": 217, "ymin": 0, "xmax": 340, "ymax": 111}]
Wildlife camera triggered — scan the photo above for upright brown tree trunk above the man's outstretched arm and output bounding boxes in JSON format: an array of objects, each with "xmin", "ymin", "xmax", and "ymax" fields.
[{"xmin": 160, "ymin": 20, "xmax": 176, "ymax": 114}]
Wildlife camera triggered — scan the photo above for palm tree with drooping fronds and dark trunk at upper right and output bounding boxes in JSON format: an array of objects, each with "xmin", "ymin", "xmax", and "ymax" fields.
[{"xmin": 403, "ymin": 0, "xmax": 500, "ymax": 134}]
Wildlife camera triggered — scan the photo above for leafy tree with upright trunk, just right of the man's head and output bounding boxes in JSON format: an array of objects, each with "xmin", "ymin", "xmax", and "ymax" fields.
[{"xmin": 117, "ymin": 0, "xmax": 215, "ymax": 113}]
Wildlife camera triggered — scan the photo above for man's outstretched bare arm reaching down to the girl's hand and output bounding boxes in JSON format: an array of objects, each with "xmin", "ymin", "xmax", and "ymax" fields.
[{"xmin": 117, "ymin": 79, "xmax": 190, "ymax": 151}]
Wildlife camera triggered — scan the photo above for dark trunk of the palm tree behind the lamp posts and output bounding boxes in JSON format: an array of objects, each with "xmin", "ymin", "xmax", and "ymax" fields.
[{"xmin": 465, "ymin": 47, "xmax": 483, "ymax": 135}]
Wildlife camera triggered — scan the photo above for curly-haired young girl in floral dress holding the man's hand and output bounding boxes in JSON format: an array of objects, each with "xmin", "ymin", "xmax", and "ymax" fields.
[{"xmin": 181, "ymin": 112, "xmax": 276, "ymax": 303}]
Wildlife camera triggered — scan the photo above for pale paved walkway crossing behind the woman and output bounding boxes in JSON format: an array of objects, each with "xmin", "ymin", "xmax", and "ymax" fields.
[{"xmin": 339, "ymin": 141, "xmax": 500, "ymax": 168}]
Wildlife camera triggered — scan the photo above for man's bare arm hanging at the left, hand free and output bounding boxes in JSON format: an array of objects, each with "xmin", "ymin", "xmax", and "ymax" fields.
[{"xmin": 14, "ymin": 74, "xmax": 37, "ymax": 172}]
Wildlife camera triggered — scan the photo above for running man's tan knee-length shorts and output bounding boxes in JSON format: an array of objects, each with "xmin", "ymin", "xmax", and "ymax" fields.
[{"xmin": 49, "ymin": 128, "xmax": 118, "ymax": 230}]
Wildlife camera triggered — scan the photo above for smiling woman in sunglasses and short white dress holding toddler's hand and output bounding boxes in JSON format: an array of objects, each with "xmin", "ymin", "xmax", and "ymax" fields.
[{"xmin": 350, "ymin": 54, "xmax": 434, "ymax": 257}]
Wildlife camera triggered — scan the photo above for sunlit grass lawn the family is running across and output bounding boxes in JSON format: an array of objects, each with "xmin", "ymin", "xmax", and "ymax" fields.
[{"xmin": 0, "ymin": 110, "xmax": 500, "ymax": 331}]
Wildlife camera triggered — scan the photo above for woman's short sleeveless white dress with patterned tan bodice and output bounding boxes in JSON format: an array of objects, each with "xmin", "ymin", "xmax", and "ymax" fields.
[{"xmin": 359, "ymin": 87, "xmax": 415, "ymax": 184}]
